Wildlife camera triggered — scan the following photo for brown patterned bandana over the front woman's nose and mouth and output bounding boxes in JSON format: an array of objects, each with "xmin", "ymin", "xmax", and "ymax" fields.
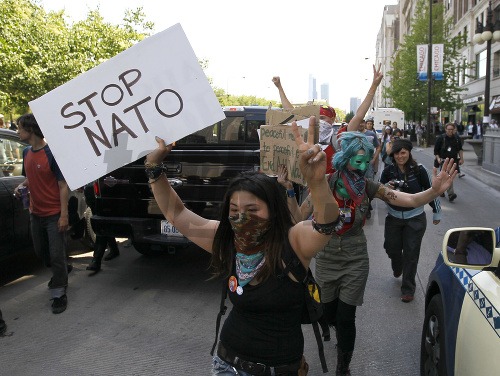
[{"xmin": 229, "ymin": 213, "xmax": 271, "ymax": 255}]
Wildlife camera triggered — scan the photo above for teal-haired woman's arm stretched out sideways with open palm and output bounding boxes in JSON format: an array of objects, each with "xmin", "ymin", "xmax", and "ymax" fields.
[{"xmin": 375, "ymin": 158, "xmax": 458, "ymax": 208}]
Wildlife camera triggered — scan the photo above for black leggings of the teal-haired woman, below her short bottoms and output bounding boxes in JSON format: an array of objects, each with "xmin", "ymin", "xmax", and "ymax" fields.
[{"xmin": 324, "ymin": 298, "xmax": 356, "ymax": 352}]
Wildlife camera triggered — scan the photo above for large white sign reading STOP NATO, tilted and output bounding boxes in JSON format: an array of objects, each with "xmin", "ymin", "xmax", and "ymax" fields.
[{"xmin": 29, "ymin": 24, "xmax": 224, "ymax": 189}]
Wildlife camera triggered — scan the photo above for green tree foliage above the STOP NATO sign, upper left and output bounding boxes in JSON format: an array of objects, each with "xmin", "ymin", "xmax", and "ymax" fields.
[{"xmin": 0, "ymin": 0, "xmax": 153, "ymax": 113}]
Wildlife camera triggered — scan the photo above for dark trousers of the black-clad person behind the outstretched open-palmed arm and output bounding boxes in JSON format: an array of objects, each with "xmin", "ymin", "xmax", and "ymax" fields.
[{"xmin": 384, "ymin": 212, "xmax": 427, "ymax": 295}]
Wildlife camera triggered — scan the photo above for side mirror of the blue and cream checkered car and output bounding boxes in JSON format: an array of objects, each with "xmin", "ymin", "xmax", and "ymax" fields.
[{"xmin": 442, "ymin": 227, "xmax": 496, "ymax": 269}]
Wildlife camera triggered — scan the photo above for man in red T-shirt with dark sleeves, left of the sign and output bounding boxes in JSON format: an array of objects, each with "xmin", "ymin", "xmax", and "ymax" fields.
[{"xmin": 14, "ymin": 114, "xmax": 72, "ymax": 314}]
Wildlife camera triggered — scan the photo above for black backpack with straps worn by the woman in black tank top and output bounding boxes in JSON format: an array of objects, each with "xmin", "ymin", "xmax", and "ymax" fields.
[{"xmin": 210, "ymin": 242, "xmax": 330, "ymax": 373}]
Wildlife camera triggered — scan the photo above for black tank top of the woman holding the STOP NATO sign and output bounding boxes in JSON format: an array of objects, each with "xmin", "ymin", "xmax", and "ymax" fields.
[{"xmin": 220, "ymin": 258, "xmax": 305, "ymax": 366}]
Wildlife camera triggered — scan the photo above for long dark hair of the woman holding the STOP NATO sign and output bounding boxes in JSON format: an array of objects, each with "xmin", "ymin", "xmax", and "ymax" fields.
[{"xmin": 210, "ymin": 171, "xmax": 293, "ymax": 280}]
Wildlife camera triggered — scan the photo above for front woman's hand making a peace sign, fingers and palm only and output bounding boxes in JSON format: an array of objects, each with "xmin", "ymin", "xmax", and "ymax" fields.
[{"xmin": 292, "ymin": 116, "xmax": 326, "ymax": 185}]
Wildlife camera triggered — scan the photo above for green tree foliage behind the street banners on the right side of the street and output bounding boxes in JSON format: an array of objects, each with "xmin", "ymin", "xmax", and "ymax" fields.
[{"xmin": 384, "ymin": 0, "xmax": 470, "ymax": 119}]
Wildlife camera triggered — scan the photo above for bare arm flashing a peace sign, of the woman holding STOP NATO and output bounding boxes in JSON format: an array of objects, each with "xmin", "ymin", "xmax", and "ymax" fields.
[{"xmin": 289, "ymin": 116, "xmax": 339, "ymax": 266}]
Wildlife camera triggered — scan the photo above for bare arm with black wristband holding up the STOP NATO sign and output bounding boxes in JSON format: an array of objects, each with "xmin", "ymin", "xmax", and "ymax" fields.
[{"xmin": 145, "ymin": 137, "xmax": 219, "ymax": 252}]
